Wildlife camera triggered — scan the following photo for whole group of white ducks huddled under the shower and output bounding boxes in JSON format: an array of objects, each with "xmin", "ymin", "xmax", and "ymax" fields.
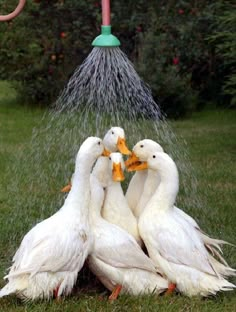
[{"xmin": 0, "ymin": 127, "xmax": 236, "ymax": 300}]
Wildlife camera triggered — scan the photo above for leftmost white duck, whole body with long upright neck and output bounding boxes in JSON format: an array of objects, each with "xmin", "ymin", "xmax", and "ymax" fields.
[{"xmin": 0, "ymin": 137, "xmax": 104, "ymax": 300}]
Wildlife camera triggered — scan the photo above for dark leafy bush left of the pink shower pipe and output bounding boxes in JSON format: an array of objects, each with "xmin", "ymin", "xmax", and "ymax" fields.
[{"xmin": 0, "ymin": 0, "xmax": 100, "ymax": 104}]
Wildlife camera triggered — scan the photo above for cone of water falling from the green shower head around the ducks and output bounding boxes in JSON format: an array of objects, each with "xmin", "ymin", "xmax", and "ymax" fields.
[{"xmin": 4, "ymin": 48, "xmax": 200, "ymax": 264}]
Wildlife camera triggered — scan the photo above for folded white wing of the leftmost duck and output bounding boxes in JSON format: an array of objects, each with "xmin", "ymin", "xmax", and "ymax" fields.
[{"xmin": 6, "ymin": 217, "xmax": 87, "ymax": 277}]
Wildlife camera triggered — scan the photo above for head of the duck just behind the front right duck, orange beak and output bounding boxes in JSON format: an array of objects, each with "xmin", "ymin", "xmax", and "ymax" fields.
[{"xmin": 125, "ymin": 139, "xmax": 164, "ymax": 171}]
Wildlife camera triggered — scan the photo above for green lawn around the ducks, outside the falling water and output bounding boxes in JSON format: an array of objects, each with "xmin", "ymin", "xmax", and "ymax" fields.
[{"xmin": 0, "ymin": 83, "xmax": 236, "ymax": 312}]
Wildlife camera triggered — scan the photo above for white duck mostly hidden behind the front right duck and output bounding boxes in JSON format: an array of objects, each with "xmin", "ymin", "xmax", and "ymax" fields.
[{"xmin": 125, "ymin": 139, "xmax": 234, "ymax": 276}]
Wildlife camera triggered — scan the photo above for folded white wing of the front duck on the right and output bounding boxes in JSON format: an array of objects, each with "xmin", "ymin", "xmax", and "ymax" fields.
[{"xmin": 152, "ymin": 214, "xmax": 216, "ymax": 275}]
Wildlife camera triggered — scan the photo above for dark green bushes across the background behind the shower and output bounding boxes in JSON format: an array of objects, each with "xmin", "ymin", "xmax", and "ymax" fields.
[{"xmin": 0, "ymin": 0, "xmax": 236, "ymax": 117}]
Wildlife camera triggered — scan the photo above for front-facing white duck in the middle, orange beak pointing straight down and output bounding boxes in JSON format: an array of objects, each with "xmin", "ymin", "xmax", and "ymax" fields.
[{"xmin": 102, "ymin": 153, "xmax": 142, "ymax": 245}]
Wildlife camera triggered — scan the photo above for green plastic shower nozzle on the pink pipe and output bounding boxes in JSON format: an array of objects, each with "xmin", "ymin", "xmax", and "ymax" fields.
[{"xmin": 92, "ymin": 25, "xmax": 120, "ymax": 47}]
